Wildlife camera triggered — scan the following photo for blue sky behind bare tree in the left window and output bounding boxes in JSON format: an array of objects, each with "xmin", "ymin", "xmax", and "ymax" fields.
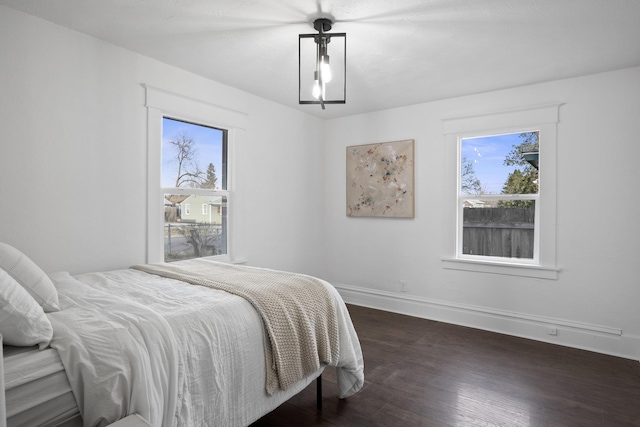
[{"xmin": 161, "ymin": 117, "xmax": 223, "ymax": 187}]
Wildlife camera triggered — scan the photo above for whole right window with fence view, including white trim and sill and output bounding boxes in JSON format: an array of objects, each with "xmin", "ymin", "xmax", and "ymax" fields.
[{"xmin": 443, "ymin": 105, "xmax": 559, "ymax": 279}]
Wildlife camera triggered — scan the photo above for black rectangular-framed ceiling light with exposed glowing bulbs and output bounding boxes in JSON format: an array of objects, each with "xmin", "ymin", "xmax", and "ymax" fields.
[{"xmin": 298, "ymin": 18, "xmax": 347, "ymax": 110}]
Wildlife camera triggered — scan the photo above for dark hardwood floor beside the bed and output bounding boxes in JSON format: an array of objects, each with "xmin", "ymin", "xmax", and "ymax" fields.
[{"xmin": 252, "ymin": 305, "xmax": 640, "ymax": 427}]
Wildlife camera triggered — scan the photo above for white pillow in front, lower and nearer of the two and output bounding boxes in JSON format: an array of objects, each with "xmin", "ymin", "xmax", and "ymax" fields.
[{"xmin": 0, "ymin": 269, "xmax": 53, "ymax": 349}]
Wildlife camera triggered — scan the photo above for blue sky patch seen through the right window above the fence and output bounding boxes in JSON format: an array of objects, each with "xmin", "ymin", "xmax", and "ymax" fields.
[{"xmin": 462, "ymin": 132, "xmax": 523, "ymax": 194}]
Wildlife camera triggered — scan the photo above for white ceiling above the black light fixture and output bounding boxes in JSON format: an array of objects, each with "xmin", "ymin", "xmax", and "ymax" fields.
[{"xmin": 0, "ymin": 0, "xmax": 640, "ymax": 118}]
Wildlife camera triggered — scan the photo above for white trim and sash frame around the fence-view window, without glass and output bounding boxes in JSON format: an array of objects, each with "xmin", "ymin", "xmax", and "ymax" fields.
[{"xmin": 442, "ymin": 104, "xmax": 561, "ymax": 279}]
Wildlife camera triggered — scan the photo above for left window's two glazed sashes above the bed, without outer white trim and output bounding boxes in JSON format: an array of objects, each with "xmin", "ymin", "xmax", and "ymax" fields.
[{"xmin": 162, "ymin": 117, "xmax": 229, "ymax": 262}]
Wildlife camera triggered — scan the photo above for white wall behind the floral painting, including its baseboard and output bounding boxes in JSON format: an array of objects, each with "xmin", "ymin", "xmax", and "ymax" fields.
[{"xmin": 325, "ymin": 68, "xmax": 640, "ymax": 359}]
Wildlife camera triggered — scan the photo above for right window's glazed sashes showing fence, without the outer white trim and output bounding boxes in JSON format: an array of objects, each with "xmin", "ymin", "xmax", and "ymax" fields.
[{"xmin": 458, "ymin": 130, "xmax": 540, "ymax": 263}]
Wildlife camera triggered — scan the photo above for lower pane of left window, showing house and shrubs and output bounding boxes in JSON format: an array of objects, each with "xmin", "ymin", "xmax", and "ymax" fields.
[{"xmin": 164, "ymin": 194, "xmax": 227, "ymax": 262}]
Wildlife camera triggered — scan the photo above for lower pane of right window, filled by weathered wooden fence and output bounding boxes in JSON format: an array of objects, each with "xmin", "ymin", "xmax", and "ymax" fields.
[{"xmin": 462, "ymin": 199, "xmax": 535, "ymax": 259}]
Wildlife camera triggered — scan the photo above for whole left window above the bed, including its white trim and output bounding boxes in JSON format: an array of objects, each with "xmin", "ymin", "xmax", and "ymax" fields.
[{"xmin": 143, "ymin": 85, "xmax": 247, "ymax": 263}]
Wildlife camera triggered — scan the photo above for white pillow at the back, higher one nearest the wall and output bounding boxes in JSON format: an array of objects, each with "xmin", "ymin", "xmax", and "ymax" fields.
[{"xmin": 0, "ymin": 242, "xmax": 60, "ymax": 313}]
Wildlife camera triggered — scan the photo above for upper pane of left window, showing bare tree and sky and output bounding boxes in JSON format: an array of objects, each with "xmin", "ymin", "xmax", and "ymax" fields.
[{"xmin": 161, "ymin": 117, "xmax": 227, "ymax": 190}]
